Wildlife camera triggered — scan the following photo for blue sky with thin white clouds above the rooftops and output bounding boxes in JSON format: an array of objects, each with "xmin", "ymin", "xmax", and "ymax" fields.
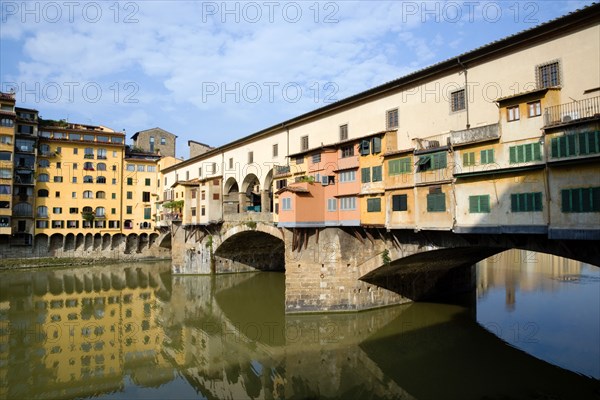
[{"xmin": 0, "ymin": 0, "xmax": 592, "ymax": 158}]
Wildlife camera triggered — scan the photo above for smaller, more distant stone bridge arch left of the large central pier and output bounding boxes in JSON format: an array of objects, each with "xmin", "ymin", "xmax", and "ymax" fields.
[{"xmin": 212, "ymin": 221, "xmax": 285, "ymax": 273}]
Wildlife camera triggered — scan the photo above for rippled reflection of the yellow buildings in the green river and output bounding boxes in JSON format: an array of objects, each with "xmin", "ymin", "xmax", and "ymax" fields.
[{"xmin": 0, "ymin": 265, "xmax": 173, "ymax": 398}]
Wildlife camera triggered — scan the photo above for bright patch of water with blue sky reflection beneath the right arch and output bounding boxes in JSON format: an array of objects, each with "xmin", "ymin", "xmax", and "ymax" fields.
[{"xmin": 477, "ymin": 250, "xmax": 600, "ymax": 378}]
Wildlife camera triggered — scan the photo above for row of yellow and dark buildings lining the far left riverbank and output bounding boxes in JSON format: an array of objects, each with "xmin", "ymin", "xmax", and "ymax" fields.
[{"xmin": 0, "ymin": 93, "xmax": 176, "ymax": 247}]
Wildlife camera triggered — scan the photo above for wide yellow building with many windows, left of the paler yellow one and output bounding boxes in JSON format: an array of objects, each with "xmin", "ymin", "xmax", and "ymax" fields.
[{"xmin": 35, "ymin": 121, "xmax": 125, "ymax": 235}]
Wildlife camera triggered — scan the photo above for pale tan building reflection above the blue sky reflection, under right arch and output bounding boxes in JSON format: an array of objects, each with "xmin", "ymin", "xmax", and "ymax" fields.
[{"xmin": 476, "ymin": 250, "xmax": 587, "ymax": 311}]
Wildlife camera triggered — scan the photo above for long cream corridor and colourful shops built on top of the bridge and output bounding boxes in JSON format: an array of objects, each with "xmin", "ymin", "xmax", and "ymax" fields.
[{"xmin": 159, "ymin": 4, "xmax": 600, "ymax": 239}]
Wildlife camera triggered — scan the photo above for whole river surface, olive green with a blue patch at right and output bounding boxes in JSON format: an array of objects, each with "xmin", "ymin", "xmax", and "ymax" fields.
[{"xmin": 0, "ymin": 251, "xmax": 600, "ymax": 399}]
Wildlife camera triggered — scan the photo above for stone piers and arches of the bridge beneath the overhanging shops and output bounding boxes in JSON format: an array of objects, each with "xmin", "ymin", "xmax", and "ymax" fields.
[{"xmin": 172, "ymin": 213, "xmax": 600, "ymax": 313}]
